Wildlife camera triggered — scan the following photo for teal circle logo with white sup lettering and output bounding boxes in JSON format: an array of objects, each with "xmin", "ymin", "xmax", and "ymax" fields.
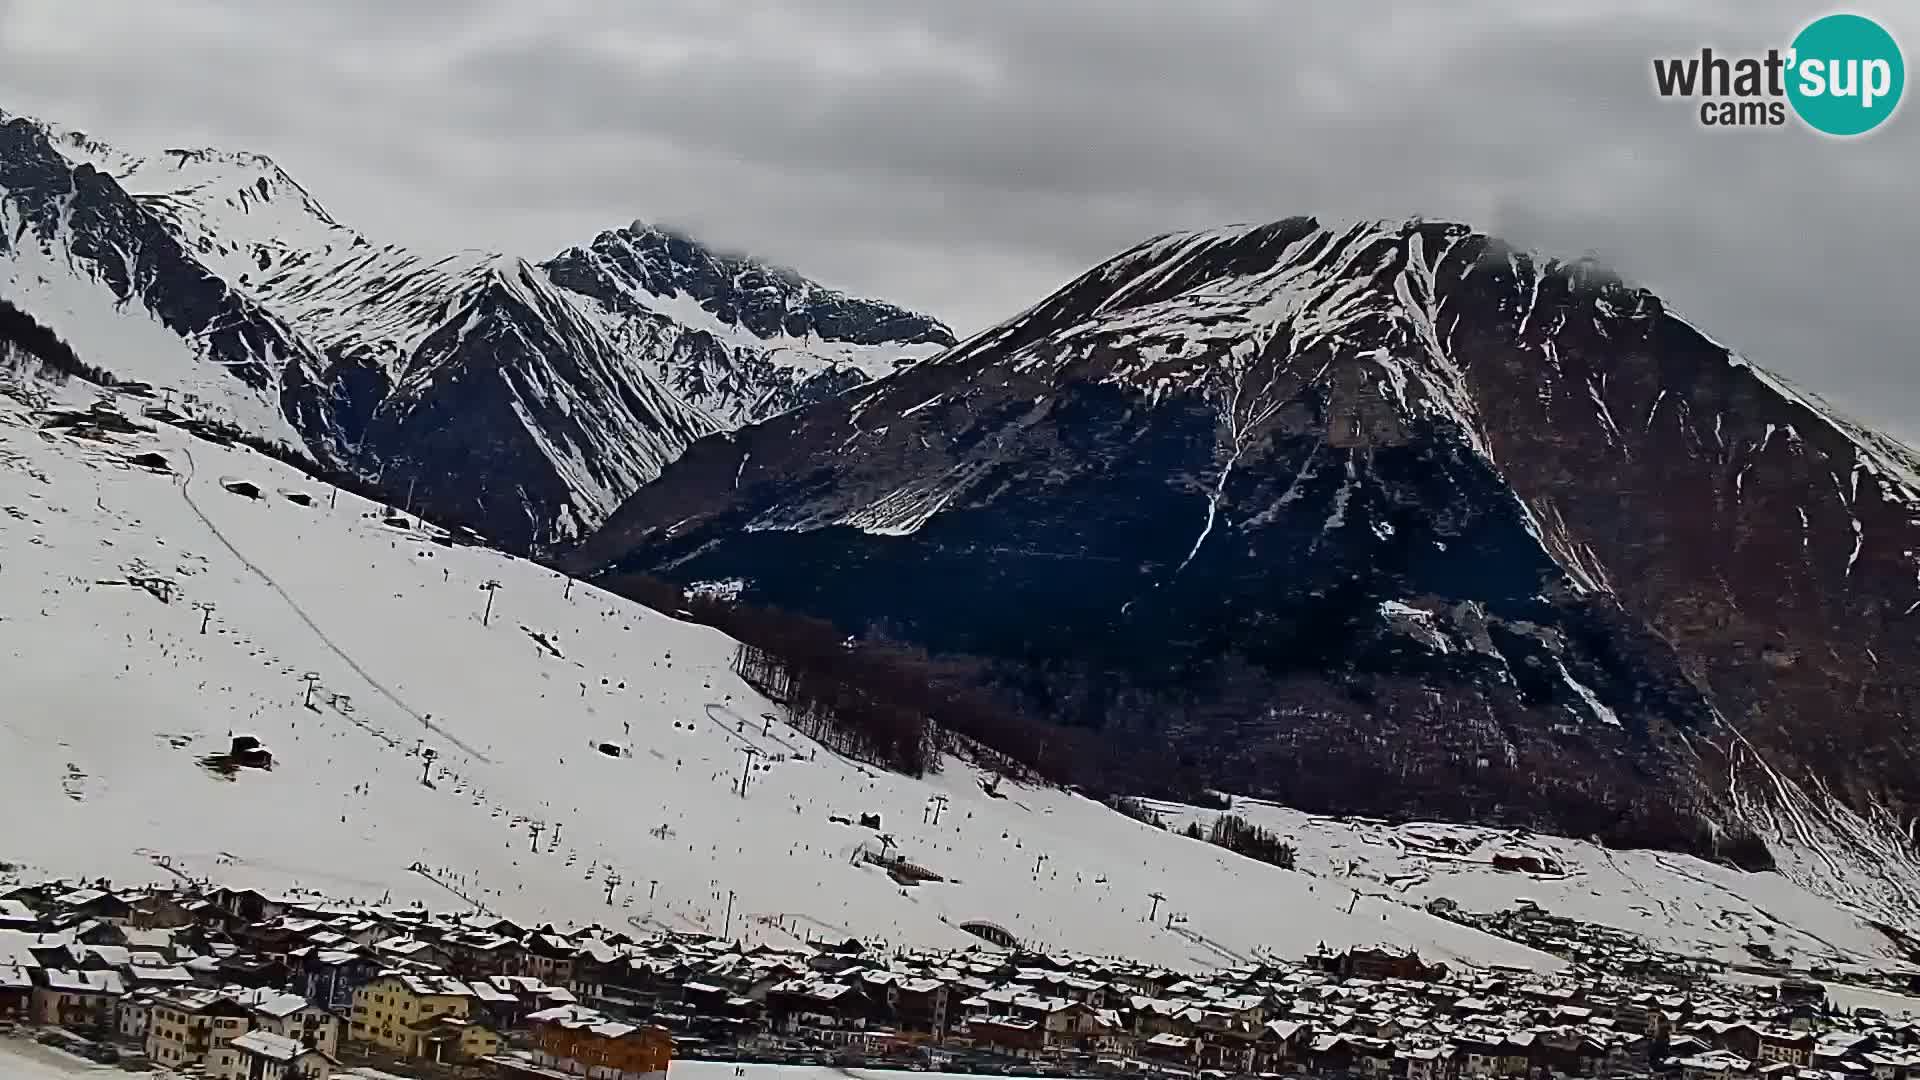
[{"xmin": 1788, "ymin": 15, "xmax": 1907, "ymax": 136}]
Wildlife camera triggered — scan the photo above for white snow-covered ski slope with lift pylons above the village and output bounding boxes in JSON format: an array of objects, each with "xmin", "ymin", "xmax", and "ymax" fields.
[{"xmin": 0, "ymin": 361, "xmax": 1891, "ymax": 970}]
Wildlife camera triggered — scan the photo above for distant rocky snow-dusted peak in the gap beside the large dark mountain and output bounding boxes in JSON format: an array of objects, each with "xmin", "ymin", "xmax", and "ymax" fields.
[{"xmin": 545, "ymin": 221, "xmax": 954, "ymax": 427}]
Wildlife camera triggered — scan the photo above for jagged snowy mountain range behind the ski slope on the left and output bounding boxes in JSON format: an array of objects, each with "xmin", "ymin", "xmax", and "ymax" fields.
[{"xmin": 0, "ymin": 109, "xmax": 952, "ymax": 550}]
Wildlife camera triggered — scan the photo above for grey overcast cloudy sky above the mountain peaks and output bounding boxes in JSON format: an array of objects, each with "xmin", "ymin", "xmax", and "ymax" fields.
[{"xmin": 0, "ymin": 0, "xmax": 1920, "ymax": 440}]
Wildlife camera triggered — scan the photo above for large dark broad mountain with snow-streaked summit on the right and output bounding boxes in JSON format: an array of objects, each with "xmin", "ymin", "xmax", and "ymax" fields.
[{"xmin": 566, "ymin": 219, "xmax": 1920, "ymax": 926}]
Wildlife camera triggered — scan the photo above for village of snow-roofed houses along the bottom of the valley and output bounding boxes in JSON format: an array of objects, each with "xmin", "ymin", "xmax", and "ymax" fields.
[{"xmin": 0, "ymin": 882, "xmax": 1920, "ymax": 1080}]
